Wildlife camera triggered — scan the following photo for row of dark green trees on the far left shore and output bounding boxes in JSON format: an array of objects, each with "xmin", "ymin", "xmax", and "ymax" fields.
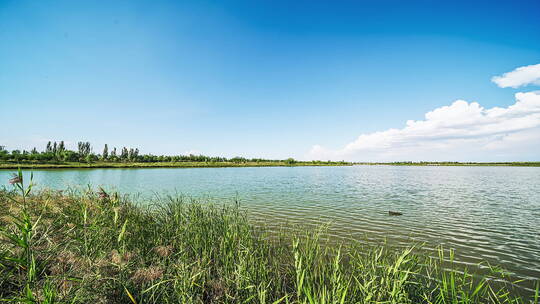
[{"xmin": 0, "ymin": 141, "xmax": 304, "ymax": 164}]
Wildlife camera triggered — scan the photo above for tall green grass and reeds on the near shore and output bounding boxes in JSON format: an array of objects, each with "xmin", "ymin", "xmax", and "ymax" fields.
[{"xmin": 0, "ymin": 180, "xmax": 538, "ymax": 303}]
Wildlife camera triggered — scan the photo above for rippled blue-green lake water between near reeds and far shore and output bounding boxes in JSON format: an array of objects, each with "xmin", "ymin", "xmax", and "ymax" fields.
[{"xmin": 0, "ymin": 166, "xmax": 540, "ymax": 290}]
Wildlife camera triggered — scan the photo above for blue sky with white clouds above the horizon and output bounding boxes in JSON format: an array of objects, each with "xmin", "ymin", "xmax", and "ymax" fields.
[{"xmin": 0, "ymin": 0, "xmax": 540, "ymax": 161}]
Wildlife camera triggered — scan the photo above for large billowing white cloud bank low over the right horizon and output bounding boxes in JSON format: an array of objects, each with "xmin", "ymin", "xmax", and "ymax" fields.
[{"xmin": 308, "ymin": 92, "xmax": 540, "ymax": 161}]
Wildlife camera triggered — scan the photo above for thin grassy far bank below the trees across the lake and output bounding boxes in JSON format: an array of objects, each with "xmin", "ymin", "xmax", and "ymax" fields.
[{"xmin": 0, "ymin": 161, "xmax": 352, "ymax": 169}]
